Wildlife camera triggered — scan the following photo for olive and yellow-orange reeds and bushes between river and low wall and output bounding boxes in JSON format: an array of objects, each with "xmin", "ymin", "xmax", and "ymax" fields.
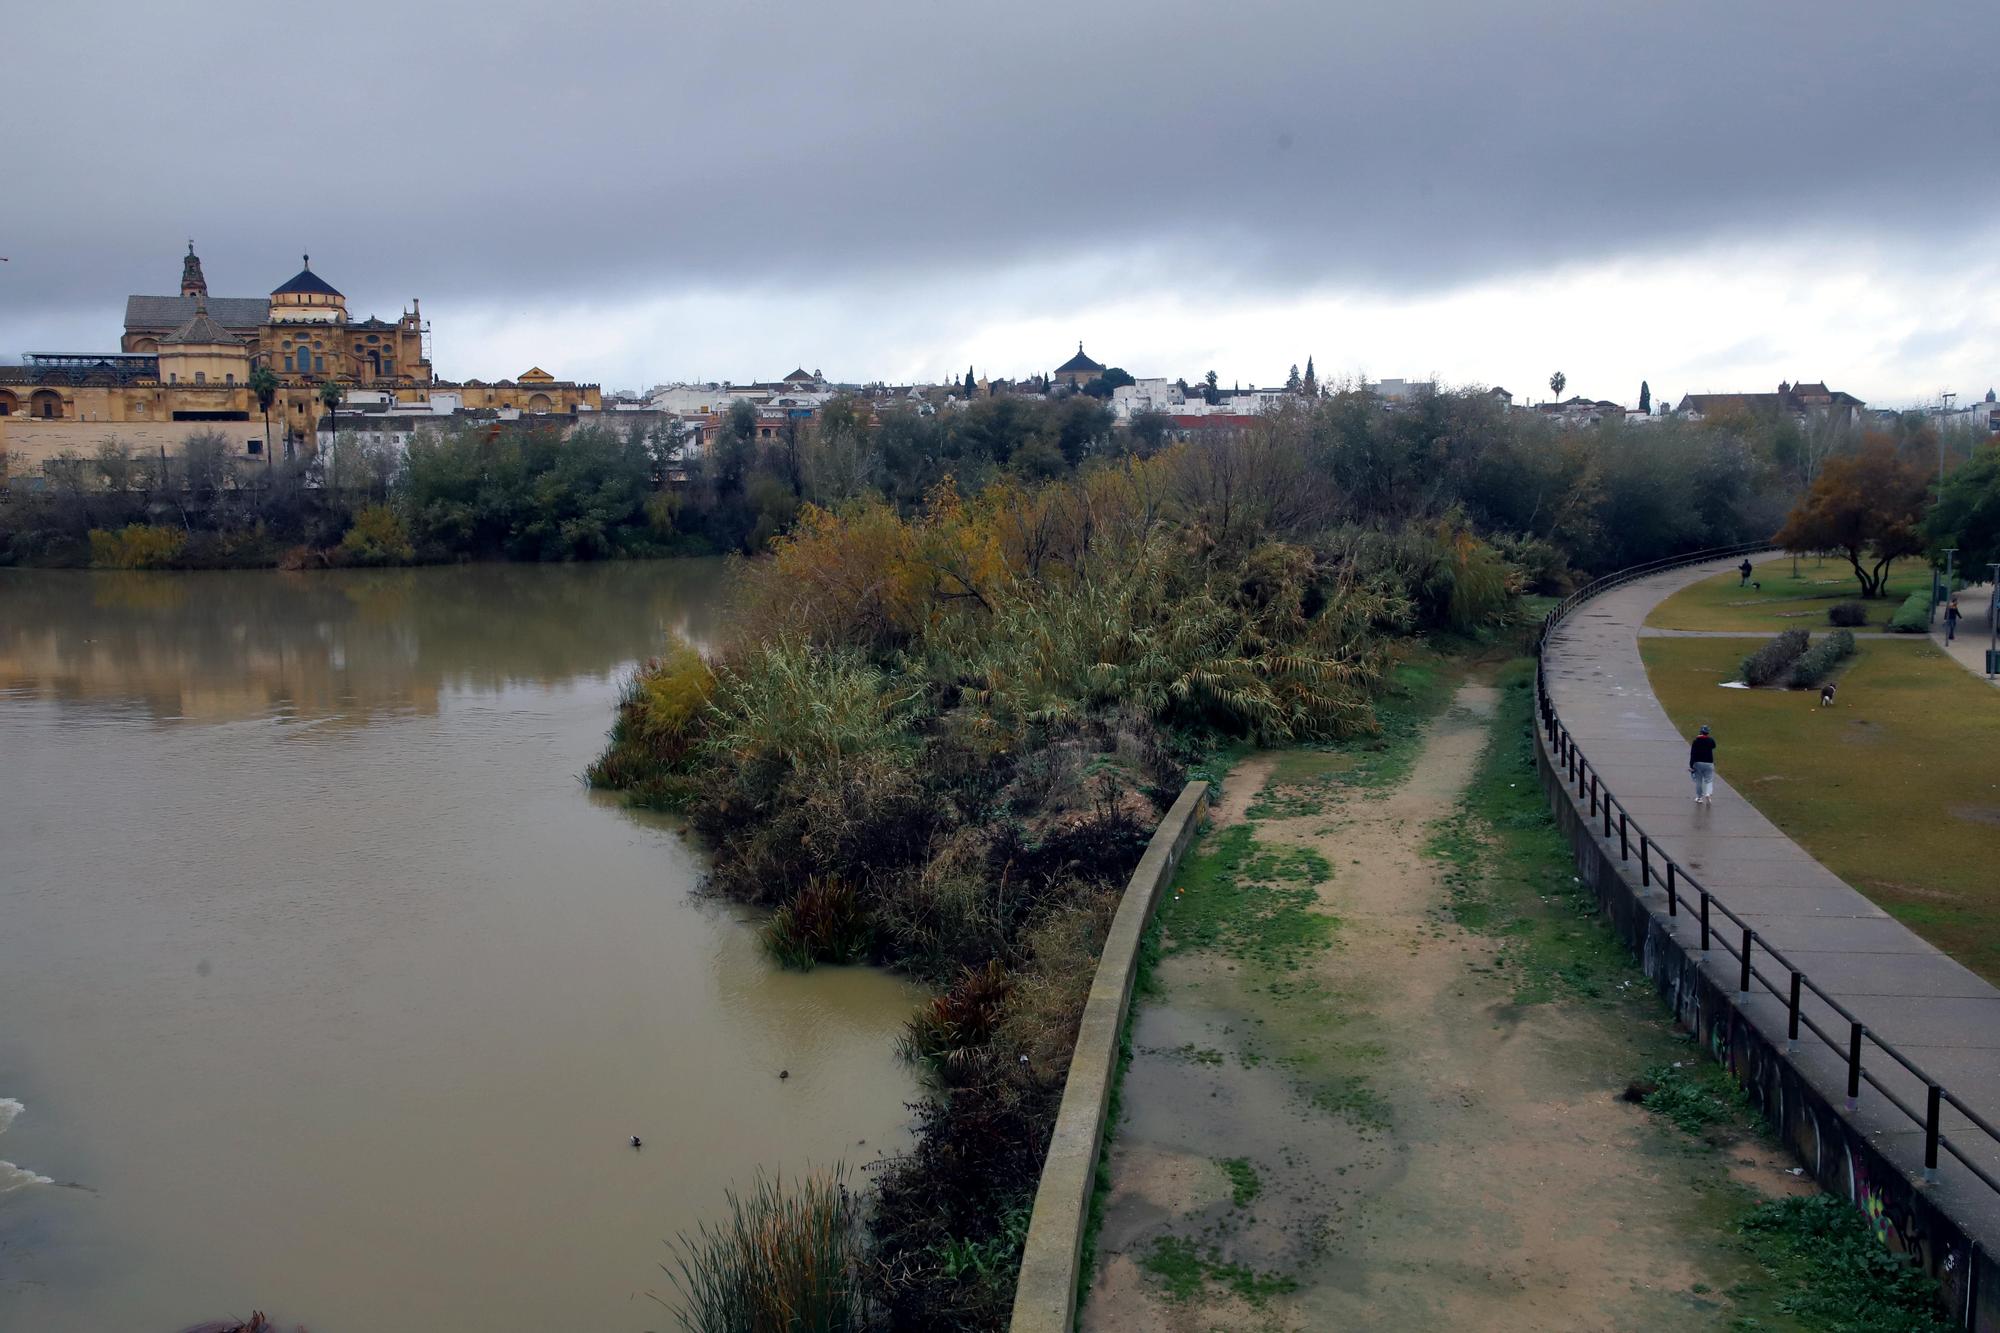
[{"xmin": 590, "ymin": 440, "xmax": 1520, "ymax": 1329}]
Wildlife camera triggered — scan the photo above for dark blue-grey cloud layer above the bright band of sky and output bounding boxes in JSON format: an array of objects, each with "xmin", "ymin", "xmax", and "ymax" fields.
[{"xmin": 0, "ymin": 0, "xmax": 2000, "ymax": 326}]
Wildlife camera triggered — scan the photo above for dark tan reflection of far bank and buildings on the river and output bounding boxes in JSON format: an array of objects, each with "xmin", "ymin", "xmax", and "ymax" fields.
[{"xmin": 0, "ymin": 560, "xmax": 722, "ymax": 721}]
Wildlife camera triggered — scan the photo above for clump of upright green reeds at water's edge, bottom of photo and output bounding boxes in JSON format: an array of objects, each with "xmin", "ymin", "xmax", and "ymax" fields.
[{"xmin": 662, "ymin": 1167, "xmax": 864, "ymax": 1333}]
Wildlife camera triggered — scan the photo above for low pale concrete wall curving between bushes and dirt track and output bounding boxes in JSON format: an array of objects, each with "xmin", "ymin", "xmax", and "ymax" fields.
[{"xmin": 1010, "ymin": 783, "xmax": 1208, "ymax": 1333}]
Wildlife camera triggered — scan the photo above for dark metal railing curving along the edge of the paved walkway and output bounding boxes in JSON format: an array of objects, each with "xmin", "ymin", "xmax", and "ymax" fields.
[{"xmin": 1534, "ymin": 542, "xmax": 2000, "ymax": 1193}]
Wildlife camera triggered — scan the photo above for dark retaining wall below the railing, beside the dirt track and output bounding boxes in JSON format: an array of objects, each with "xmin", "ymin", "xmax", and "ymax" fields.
[{"xmin": 1536, "ymin": 727, "xmax": 2000, "ymax": 1333}]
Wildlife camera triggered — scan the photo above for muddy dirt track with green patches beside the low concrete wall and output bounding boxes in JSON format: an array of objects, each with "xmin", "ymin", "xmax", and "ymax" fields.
[{"xmin": 1082, "ymin": 681, "xmax": 1808, "ymax": 1331}]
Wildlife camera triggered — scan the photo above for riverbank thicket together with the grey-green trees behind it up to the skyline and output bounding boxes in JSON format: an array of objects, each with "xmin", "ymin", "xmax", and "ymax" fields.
[{"xmin": 590, "ymin": 394, "xmax": 1984, "ymax": 1329}]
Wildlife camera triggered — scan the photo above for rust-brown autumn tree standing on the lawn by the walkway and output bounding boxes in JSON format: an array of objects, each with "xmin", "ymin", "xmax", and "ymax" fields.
[{"xmin": 1776, "ymin": 434, "xmax": 1928, "ymax": 596}]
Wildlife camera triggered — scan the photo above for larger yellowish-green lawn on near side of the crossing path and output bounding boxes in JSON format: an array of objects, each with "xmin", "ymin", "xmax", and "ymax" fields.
[{"xmin": 1640, "ymin": 628, "xmax": 2000, "ymax": 983}]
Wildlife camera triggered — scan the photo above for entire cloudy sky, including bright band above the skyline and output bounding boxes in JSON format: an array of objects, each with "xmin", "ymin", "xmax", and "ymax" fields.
[{"xmin": 0, "ymin": 0, "xmax": 2000, "ymax": 404}]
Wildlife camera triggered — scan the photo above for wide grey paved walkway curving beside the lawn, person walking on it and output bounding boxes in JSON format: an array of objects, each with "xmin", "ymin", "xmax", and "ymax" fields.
[{"xmin": 1544, "ymin": 560, "xmax": 2000, "ymax": 1241}]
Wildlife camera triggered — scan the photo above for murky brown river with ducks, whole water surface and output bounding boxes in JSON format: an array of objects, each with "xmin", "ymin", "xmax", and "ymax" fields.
[{"xmin": 0, "ymin": 560, "xmax": 914, "ymax": 1333}]
